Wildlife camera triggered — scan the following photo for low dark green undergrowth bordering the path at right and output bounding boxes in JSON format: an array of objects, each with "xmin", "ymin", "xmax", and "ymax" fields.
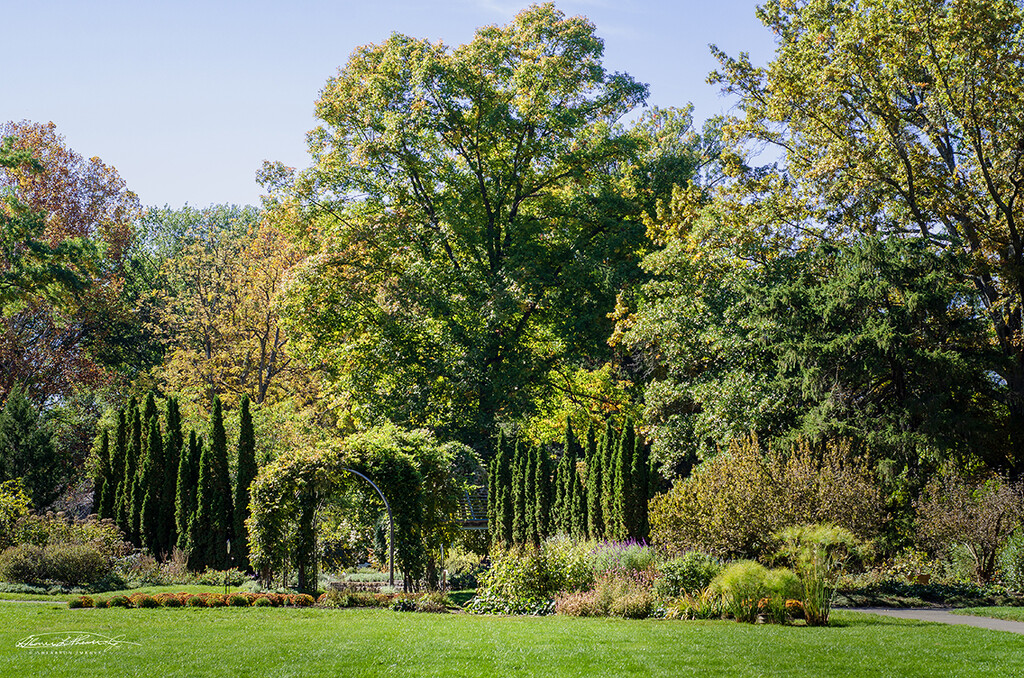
[{"xmin": 834, "ymin": 581, "xmax": 1024, "ymax": 607}]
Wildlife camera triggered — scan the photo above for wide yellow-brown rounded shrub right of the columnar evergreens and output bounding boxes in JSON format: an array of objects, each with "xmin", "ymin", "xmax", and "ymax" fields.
[{"xmin": 650, "ymin": 437, "xmax": 883, "ymax": 556}]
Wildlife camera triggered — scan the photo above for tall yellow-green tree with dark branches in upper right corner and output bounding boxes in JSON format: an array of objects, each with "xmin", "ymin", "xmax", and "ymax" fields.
[{"xmin": 713, "ymin": 0, "xmax": 1024, "ymax": 474}]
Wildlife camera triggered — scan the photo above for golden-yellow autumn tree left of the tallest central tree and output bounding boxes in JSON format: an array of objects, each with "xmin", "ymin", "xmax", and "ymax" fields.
[{"xmin": 143, "ymin": 206, "xmax": 308, "ymax": 411}]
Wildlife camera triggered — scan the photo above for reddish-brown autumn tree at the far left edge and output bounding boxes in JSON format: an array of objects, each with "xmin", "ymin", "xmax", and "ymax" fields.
[{"xmin": 0, "ymin": 122, "xmax": 139, "ymax": 404}]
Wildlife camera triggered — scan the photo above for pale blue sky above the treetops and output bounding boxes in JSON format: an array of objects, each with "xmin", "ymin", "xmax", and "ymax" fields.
[{"xmin": 0, "ymin": 0, "xmax": 773, "ymax": 207}]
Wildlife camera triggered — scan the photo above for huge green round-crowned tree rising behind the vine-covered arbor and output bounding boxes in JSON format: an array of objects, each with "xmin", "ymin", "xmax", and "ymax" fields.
[{"xmin": 263, "ymin": 3, "xmax": 651, "ymax": 452}]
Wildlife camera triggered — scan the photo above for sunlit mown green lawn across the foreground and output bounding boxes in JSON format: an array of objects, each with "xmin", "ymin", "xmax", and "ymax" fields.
[{"xmin": 0, "ymin": 602, "xmax": 1024, "ymax": 678}]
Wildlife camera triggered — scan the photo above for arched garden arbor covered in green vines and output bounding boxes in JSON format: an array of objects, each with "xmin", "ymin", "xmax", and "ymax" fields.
[{"xmin": 247, "ymin": 425, "xmax": 481, "ymax": 590}]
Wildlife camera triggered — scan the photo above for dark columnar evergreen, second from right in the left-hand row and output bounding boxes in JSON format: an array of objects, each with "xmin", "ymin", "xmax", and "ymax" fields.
[{"xmin": 188, "ymin": 397, "xmax": 233, "ymax": 569}]
